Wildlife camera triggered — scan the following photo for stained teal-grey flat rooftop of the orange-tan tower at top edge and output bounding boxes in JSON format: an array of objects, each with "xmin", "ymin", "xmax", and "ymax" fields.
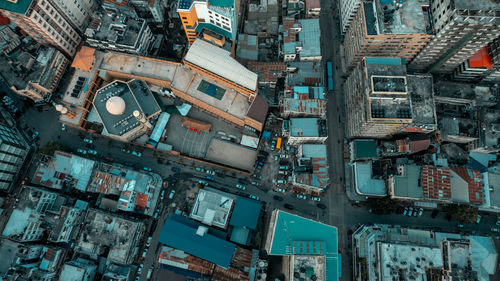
[{"xmin": 364, "ymin": 0, "xmax": 431, "ymax": 35}]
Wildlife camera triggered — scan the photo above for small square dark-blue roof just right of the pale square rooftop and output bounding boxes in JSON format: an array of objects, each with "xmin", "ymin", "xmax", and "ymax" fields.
[{"xmin": 229, "ymin": 197, "xmax": 262, "ymax": 230}]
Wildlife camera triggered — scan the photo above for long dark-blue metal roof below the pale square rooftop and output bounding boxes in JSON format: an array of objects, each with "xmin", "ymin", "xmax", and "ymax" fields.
[{"xmin": 158, "ymin": 214, "xmax": 236, "ymax": 269}]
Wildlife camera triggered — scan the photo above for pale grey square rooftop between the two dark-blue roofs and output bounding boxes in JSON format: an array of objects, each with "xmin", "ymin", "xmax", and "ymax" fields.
[{"xmin": 189, "ymin": 189, "xmax": 234, "ymax": 229}]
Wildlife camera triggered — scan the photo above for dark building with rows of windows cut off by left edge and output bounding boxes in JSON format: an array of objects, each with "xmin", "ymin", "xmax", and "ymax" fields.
[{"xmin": 0, "ymin": 108, "xmax": 30, "ymax": 192}]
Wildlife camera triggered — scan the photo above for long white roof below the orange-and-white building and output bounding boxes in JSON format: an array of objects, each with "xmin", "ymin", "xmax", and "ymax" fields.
[{"xmin": 184, "ymin": 39, "xmax": 257, "ymax": 91}]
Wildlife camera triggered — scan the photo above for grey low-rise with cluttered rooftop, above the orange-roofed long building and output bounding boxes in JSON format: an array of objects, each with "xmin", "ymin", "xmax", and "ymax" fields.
[{"xmin": 85, "ymin": 9, "xmax": 153, "ymax": 55}]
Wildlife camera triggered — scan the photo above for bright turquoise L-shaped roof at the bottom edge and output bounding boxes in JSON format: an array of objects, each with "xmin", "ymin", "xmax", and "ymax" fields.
[{"xmin": 266, "ymin": 210, "xmax": 339, "ymax": 281}]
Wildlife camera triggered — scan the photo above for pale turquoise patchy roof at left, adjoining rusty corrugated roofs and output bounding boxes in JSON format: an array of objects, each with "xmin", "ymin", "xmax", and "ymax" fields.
[{"xmin": 32, "ymin": 151, "xmax": 95, "ymax": 191}]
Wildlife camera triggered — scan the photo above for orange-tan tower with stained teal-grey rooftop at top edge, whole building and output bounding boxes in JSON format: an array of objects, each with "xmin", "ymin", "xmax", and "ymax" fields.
[{"xmin": 344, "ymin": 0, "xmax": 433, "ymax": 68}]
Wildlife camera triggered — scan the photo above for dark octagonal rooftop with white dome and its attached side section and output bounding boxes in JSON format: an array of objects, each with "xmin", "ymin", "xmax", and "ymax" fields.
[{"xmin": 94, "ymin": 80, "xmax": 161, "ymax": 136}]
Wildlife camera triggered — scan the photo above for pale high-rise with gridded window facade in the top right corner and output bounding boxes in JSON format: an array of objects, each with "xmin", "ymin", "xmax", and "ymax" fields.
[{"xmin": 409, "ymin": 0, "xmax": 500, "ymax": 73}]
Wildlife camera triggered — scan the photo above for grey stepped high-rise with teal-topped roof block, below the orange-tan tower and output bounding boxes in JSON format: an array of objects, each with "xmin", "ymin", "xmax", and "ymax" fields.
[{"xmin": 345, "ymin": 57, "xmax": 437, "ymax": 138}]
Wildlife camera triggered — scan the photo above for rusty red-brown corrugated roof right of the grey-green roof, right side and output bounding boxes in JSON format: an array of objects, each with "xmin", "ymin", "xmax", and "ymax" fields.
[{"xmin": 420, "ymin": 166, "xmax": 451, "ymax": 200}]
